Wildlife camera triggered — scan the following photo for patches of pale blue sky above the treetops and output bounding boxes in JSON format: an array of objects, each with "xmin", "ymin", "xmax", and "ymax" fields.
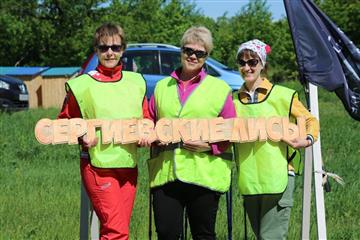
[{"xmin": 194, "ymin": 0, "xmax": 286, "ymax": 20}]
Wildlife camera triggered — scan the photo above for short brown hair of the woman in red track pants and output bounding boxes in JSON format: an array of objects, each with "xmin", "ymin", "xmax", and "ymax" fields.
[{"xmin": 93, "ymin": 23, "xmax": 126, "ymax": 50}]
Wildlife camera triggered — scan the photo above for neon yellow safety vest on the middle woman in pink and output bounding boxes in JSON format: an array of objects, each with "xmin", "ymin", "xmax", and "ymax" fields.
[{"xmin": 148, "ymin": 75, "xmax": 232, "ymax": 192}]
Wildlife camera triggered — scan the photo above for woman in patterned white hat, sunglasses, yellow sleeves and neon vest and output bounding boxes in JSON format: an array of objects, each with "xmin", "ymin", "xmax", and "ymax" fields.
[{"xmin": 233, "ymin": 39, "xmax": 319, "ymax": 239}]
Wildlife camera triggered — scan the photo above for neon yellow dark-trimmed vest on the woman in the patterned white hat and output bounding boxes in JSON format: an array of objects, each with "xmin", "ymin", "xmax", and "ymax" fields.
[{"xmin": 234, "ymin": 85, "xmax": 297, "ymax": 195}]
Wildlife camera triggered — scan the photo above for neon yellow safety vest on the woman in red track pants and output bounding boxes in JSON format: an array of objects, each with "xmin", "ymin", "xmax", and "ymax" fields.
[{"xmin": 66, "ymin": 71, "xmax": 146, "ymax": 168}]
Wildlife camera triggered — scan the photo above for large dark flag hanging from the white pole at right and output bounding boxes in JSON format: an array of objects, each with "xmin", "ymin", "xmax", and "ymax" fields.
[{"xmin": 284, "ymin": 0, "xmax": 360, "ymax": 121}]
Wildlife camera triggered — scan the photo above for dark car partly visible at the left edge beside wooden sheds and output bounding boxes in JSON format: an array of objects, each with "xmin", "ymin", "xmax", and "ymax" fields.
[{"xmin": 0, "ymin": 75, "xmax": 29, "ymax": 111}]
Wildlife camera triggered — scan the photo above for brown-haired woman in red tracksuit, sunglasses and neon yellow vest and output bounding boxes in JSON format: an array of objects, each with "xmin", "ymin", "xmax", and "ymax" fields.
[{"xmin": 58, "ymin": 23, "xmax": 148, "ymax": 239}]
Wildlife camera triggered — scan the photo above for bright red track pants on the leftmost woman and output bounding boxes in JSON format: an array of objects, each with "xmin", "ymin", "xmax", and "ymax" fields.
[{"xmin": 80, "ymin": 159, "xmax": 138, "ymax": 240}]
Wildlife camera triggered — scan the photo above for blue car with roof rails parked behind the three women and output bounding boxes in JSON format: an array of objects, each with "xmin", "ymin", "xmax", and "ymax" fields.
[{"xmin": 81, "ymin": 43, "xmax": 244, "ymax": 97}]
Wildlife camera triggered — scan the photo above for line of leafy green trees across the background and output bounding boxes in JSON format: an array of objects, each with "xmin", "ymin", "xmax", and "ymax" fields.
[{"xmin": 0, "ymin": 0, "xmax": 360, "ymax": 81}]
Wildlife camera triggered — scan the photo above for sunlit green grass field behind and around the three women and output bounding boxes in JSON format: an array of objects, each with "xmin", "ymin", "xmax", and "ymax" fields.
[{"xmin": 0, "ymin": 82, "xmax": 360, "ymax": 240}]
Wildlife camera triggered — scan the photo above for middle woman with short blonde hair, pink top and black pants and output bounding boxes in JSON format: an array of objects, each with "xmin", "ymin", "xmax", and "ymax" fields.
[{"xmin": 142, "ymin": 27, "xmax": 236, "ymax": 240}]
